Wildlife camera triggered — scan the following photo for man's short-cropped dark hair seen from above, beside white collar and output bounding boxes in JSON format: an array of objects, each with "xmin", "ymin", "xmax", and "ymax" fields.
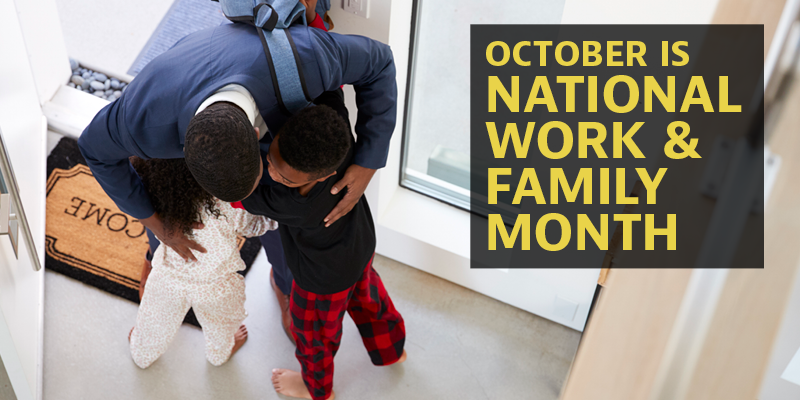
[{"xmin": 183, "ymin": 102, "xmax": 262, "ymax": 202}]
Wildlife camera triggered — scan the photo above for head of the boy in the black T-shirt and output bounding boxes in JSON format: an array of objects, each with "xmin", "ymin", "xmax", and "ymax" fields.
[{"xmin": 267, "ymin": 105, "xmax": 352, "ymax": 187}]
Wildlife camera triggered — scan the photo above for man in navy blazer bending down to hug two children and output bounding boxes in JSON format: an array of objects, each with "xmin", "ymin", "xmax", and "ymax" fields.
[{"xmin": 78, "ymin": 7, "xmax": 397, "ymax": 340}]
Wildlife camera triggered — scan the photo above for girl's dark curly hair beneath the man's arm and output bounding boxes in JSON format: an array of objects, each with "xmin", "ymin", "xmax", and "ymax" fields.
[{"xmin": 130, "ymin": 157, "xmax": 220, "ymax": 236}]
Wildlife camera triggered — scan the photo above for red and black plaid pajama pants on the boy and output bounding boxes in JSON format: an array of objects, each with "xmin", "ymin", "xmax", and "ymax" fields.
[{"xmin": 289, "ymin": 256, "xmax": 406, "ymax": 400}]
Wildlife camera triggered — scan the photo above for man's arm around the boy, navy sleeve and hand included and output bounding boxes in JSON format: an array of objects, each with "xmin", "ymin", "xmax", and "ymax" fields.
[{"xmin": 306, "ymin": 33, "xmax": 397, "ymax": 226}]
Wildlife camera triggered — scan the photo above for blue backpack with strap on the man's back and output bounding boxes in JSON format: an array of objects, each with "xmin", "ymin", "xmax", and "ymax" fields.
[{"xmin": 212, "ymin": 0, "xmax": 330, "ymax": 115}]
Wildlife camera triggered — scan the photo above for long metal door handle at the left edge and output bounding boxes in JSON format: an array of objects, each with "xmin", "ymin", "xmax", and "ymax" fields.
[{"xmin": 0, "ymin": 130, "xmax": 42, "ymax": 271}]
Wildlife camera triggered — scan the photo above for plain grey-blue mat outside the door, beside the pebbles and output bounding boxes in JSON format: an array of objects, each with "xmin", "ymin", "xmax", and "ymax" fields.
[{"xmin": 128, "ymin": 0, "xmax": 228, "ymax": 76}]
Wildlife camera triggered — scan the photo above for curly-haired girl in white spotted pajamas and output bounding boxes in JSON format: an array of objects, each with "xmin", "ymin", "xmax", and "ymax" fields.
[{"xmin": 129, "ymin": 158, "xmax": 277, "ymax": 368}]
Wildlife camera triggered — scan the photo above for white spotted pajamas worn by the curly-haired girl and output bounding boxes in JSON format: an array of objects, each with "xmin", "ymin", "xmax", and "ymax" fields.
[{"xmin": 130, "ymin": 202, "xmax": 277, "ymax": 368}]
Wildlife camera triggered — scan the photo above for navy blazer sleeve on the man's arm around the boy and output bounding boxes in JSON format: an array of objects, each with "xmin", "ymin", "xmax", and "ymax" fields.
[{"xmin": 309, "ymin": 29, "xmax": 397, "ymax": 169}]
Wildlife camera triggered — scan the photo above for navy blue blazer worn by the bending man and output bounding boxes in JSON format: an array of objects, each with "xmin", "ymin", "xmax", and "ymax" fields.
[{"xmin": 78, "ymin": 23, "xmax": 397, "ymax": 219}]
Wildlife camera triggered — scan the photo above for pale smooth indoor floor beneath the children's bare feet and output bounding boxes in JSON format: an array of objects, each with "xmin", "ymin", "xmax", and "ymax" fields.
[{"xmin": 44, "ymin": 253, "xmax": 580, "ymax": 400}]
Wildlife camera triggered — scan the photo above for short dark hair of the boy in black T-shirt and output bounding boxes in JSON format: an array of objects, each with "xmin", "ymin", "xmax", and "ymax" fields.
[{"xmin": 278, "ymin": 105, "xmax": 352, "ymax": 179}]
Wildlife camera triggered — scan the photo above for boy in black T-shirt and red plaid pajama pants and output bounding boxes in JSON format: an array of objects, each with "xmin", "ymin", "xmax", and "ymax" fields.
[{"xmin": 233, "ymin": 90, "xmax": 406, "ymax": 400}]
